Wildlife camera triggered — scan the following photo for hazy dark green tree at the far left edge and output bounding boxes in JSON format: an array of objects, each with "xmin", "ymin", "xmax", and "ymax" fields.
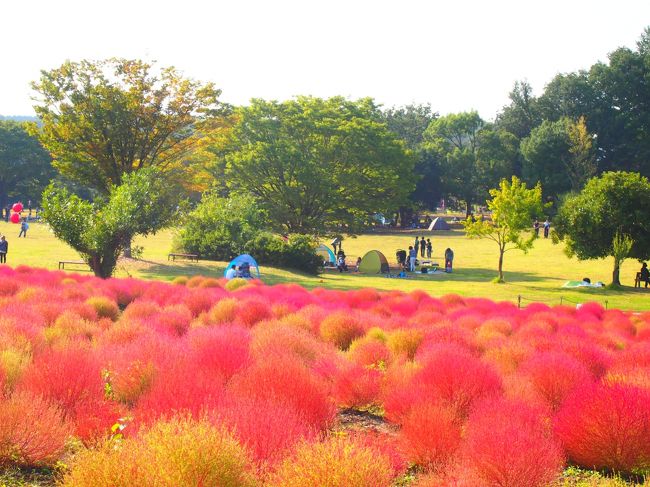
[{"xmin": 0, "ymin": 121, "xmax": 54, "ymax": 208}]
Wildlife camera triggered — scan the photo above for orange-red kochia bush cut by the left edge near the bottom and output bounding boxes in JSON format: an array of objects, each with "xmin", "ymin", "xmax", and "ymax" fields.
[{"xmin": 0, "ymin": 392, "xmax": 69, "ymax": 467}]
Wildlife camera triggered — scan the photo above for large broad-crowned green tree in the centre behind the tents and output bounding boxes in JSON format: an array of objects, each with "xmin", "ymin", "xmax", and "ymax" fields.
[{"xmin": 225, "ymin": 97, "xmax": 414, "ymax": 233}]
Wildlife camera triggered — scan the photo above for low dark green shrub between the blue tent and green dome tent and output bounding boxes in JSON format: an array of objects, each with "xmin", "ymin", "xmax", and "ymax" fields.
[{"xmin": 245, "ymin": 232, "xmax": 323, "ymax": 274}]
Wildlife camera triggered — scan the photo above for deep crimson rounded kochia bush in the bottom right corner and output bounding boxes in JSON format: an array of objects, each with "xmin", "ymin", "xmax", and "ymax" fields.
[{"xmin": 555, "ymin": 384, "xmax": 650, "ymax": 472}]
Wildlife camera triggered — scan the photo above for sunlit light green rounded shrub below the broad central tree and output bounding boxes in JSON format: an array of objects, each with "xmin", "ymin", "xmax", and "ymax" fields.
[{"xmin": 176, "ymin": 193, "xmax": 267, "ymax": 260}]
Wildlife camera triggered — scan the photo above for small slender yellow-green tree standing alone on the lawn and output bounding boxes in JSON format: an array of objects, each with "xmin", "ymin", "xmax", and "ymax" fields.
[{"xmin": 463, "ymin": 176, "xmax": 544, "ymax": 282}]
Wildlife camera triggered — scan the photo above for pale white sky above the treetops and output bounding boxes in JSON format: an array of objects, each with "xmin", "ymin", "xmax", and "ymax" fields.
[{"xmin": 0, "ymin": 0, "xmax": 650, "ymax": 119}]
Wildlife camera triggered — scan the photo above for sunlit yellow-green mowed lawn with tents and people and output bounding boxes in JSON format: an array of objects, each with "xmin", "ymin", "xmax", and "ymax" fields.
[{"xmin": 0, "ymin": 221, "xmax": 650, "ymax": 311}]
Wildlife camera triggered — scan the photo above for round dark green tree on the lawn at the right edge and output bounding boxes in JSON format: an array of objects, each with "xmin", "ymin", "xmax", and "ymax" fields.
[{"xmin": 554, "ymin": 171, "xmax": 650, "ymax": 285}]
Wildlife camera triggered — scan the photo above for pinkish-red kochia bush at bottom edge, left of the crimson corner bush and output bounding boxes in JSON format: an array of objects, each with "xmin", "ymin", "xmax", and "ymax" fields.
[{"xmin": 459, "ymin": 398, "xmax": 564, "ymax": 487}]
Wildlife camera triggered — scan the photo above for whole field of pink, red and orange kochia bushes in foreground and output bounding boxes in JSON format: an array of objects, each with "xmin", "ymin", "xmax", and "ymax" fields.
[{"xmin": 0, "ymin": 266, "xmax": 650, "ymax": 486}]
